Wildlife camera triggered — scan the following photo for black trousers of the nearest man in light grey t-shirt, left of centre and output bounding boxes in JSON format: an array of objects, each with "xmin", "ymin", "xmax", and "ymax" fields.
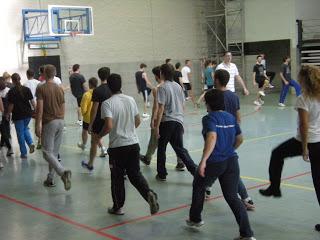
[{"xmin": 108, "ymin": 144, "xmax": 152, "ymax": 209}]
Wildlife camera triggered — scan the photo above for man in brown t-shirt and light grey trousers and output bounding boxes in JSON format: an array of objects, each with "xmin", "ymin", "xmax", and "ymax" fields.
[{"xmin": 36, "ymin": 65, "xmax": 71, "ymax": 191}]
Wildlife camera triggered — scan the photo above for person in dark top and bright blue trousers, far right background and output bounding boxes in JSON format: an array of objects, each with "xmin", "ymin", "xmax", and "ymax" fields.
[{"xmin": 279, "ymin": 57, "xmax": 301, "ymax": 107}]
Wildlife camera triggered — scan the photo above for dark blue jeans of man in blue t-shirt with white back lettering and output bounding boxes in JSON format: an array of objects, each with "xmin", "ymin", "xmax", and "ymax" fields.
[{"xmin": 189, "ymin": 157, "xmax": 253, "ymax": 237}]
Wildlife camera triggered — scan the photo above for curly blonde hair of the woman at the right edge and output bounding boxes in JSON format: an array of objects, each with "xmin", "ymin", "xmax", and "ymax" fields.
[{"xmin": 299, "ymin": 65, "xmax": 320, "ymax": 98}]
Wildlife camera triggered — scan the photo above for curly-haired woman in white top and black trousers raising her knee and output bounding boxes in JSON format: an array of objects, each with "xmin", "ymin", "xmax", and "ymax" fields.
[{"xmin": 260, "ymin": 66, "xmax": 320, "ymax": 231}]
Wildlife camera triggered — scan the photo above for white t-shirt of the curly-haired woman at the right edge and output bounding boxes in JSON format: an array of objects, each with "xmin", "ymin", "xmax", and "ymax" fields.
[{"xmin": 295, "ymin": 95, "xmax": 320, "ymax": 143}]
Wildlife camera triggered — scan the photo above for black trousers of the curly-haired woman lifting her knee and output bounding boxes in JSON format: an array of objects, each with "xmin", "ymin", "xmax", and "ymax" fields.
[{"xmin": 269, "ymin": 138, "xmax": 320, "ymax": 205}]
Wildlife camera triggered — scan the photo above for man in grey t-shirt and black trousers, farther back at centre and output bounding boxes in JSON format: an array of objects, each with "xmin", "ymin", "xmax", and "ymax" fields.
[{"xmin": 155, "ymin": 64, "xmax": 197, "ymax": 181}]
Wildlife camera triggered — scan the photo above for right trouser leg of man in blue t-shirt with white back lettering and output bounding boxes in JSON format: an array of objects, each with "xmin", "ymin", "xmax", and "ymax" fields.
[{"xmin": 219, "ymin": 157, "xmax": 253, "ymax": 237}]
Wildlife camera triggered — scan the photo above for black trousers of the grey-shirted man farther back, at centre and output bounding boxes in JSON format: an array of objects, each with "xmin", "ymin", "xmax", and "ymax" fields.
[{"xmin": 157, "ymin": 121, "xmax": 197, "ymax": 177}]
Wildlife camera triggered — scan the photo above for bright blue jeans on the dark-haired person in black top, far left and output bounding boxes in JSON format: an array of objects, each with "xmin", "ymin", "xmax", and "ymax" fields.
[{"xmin": 14, "ymin": 118, "xmax": 33, "ymax": 156}]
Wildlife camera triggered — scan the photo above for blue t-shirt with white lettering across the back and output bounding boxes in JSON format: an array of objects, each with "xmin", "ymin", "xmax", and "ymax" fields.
[{"xmin": 202, "ymin": 111, "xmax": 241, "ymax": 163}]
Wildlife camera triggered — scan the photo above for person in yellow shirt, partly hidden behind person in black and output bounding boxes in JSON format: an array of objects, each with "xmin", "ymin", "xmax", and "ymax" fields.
[{"xmin": 78, "ymin": 77, "xmax": 105, "ymax": 157}]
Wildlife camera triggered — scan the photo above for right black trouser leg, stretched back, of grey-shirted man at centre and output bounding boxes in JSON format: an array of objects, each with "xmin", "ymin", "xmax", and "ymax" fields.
[{"xmin": 170, "ymin": 122, "xmax": 197, "ymax": 175}]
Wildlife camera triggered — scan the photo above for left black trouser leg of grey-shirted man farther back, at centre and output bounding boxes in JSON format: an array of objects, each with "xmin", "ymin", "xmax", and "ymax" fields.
[{"xmin": 157, "ymin": 122, "xmax": 174, "ymax": 179}]
